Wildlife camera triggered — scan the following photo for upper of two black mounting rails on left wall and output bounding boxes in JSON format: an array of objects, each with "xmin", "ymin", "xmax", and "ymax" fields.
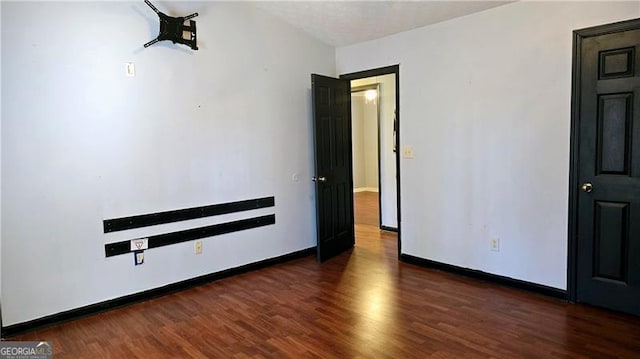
[{"xmin": 102, "ymin": 197, "xmax": 275, "ymax": 233}]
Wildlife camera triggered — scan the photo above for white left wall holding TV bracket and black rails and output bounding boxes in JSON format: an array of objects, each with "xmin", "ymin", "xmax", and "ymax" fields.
[{"xmin": 1, "ymin": 2, "xmax": 335, "ymax": 326}]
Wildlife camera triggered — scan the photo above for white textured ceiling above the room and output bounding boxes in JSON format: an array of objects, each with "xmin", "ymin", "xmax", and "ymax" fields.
[{"xmin": 256, "ymin": 0, "xmax": 511, "ymax": 46}]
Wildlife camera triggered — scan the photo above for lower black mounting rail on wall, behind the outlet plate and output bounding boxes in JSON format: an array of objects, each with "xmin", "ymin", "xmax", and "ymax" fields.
[{"xmin": 104, "ymin": 214, "xmax": 276, "ymax": 257}]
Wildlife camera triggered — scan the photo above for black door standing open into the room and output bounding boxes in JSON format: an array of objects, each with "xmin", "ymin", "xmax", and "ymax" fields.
[{"xmin": 311, "ymin": 74, "xmax": 355, "ymax": 262}]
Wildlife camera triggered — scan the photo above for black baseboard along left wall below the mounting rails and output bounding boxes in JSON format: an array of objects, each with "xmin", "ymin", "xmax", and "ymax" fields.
[{"xmin": 1, "ymin": 247, "xmax": 316, "ymax": 339}]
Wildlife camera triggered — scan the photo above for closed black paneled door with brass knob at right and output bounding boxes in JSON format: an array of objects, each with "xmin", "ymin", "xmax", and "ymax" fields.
[{"xmin": 576, "ymin": 24, "xmax": 640, "ymax": 315}]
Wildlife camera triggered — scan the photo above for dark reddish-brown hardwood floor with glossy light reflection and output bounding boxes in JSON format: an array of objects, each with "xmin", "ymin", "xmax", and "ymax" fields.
[{"xmin": 6, "ymin": 194, "xmax": 640, "ymax": 358}]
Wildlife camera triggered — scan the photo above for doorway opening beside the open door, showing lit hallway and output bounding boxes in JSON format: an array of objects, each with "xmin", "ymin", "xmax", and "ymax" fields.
[{"xmin": 341, "ymin": 66, "xmax": 400, "ymax": 256}]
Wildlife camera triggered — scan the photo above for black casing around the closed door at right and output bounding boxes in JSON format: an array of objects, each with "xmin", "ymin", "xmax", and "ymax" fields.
[{"xmin": 567, "ymin": 19, "xmax": 640, "ymax": 302}]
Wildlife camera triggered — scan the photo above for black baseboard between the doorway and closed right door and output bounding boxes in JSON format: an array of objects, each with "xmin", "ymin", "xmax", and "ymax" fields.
[{"xmin": 400, "ymin": 254, "xmax": 567, "ymax": 300}]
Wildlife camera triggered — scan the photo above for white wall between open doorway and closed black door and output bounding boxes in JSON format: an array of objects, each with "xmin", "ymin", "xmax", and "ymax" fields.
[{"xmin": 336, "ymin": 2, "xmax": 640, "ymax": 289}]
